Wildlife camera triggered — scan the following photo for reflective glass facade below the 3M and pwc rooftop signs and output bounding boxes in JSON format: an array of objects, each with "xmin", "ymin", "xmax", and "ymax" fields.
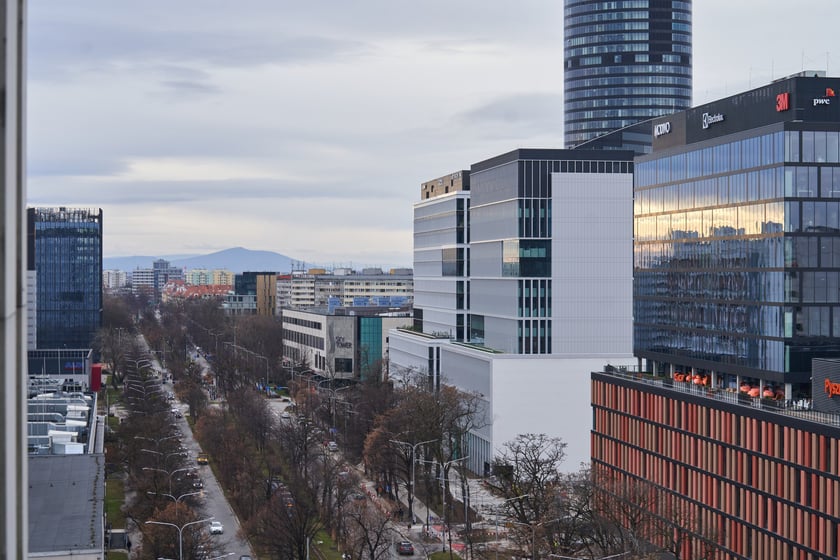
[{"xmin": 634, "ymin": 123, "xmax": 840, "ymax": 382}]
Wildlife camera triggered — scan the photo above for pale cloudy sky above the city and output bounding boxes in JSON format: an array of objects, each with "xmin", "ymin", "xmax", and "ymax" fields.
[{"xmin": 27, "ymin": 0, "xmax": 840, "ymax": 268}]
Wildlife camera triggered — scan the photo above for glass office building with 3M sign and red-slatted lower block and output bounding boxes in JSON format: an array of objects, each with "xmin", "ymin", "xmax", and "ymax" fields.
[{"xmin": 592, "ymin": 72, "xmax": 840, "ymax": 559}]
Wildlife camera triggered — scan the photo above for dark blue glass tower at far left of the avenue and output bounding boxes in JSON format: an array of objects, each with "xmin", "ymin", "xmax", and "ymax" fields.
[{"xmin": 28, "ymin": 207, "xmax": 102, "ymax": 349}]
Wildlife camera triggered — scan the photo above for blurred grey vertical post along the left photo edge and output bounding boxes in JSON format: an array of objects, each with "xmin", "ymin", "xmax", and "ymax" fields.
[{"xmin": 0, "ymin": 0, "xmax": 29, "ymax": 558}]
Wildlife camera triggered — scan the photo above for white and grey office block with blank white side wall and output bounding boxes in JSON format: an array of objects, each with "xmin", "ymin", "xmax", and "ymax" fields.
[{"xmin": 389, "ymin": 149, "xmax": 633, "ymax": 472}]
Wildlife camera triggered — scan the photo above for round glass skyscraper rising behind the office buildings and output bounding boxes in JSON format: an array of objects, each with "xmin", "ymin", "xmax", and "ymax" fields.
[{"xmin": 563, "ymin": 0, "xmax": 691, "ymax": 148}]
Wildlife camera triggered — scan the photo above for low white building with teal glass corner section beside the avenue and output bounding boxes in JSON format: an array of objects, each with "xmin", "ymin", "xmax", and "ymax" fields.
[{"xmin": 282, "ymin": 307, "xmax": 411, "ymax": 379}]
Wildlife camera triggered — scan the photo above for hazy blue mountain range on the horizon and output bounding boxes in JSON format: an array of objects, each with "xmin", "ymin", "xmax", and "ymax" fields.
[{"xmin": 102, "ymin": 247, "xmax": 292, "ymax": 274}]
